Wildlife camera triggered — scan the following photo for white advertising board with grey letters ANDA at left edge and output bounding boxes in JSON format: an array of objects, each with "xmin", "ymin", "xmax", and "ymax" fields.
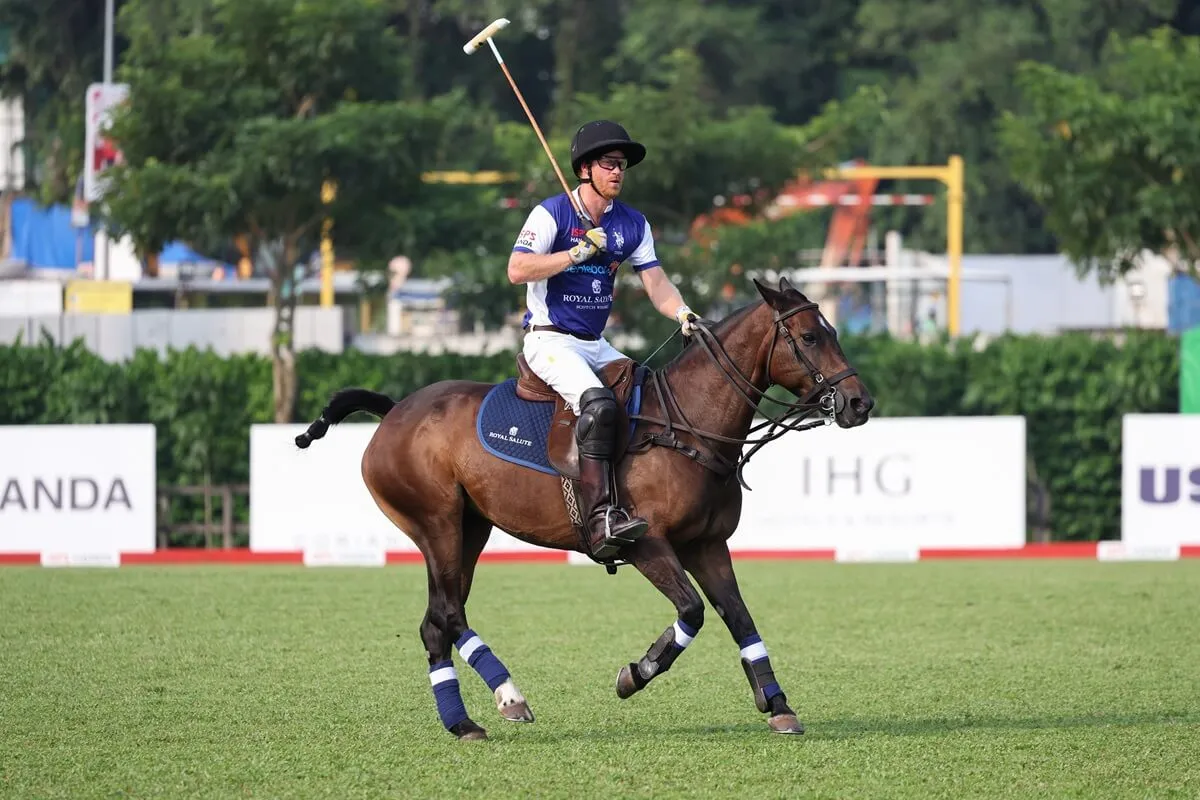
[{"xmin": 0, "ymin": 425, "xmax": 156, "ymax": 554}]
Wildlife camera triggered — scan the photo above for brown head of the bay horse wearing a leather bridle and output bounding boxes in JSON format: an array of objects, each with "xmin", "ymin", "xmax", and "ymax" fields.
[{"xmin": 754, "ymin": 277, "xmax": 875, "ymax": 428}]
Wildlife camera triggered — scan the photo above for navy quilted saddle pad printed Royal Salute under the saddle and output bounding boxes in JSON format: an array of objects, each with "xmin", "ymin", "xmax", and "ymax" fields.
[{"xmin": 475, "ymin": 369, "xmax": 642, "ymax": 475}]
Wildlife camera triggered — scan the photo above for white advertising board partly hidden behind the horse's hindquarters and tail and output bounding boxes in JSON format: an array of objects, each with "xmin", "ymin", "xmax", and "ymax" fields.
[{"xmin": 250, "ymin": 423, "xmax": 545, "ymax": 563}]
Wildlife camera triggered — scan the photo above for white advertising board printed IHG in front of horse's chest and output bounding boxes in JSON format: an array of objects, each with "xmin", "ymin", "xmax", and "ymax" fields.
[{"xmin": 730, "ymin": 416, "xmax": 1025, "ymax": 560}]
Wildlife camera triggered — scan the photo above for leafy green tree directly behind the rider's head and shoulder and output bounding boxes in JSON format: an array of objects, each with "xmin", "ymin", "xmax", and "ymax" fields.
[{"xmin": 576, "ymin": 56, "xmax": 882, "ymax": 338}]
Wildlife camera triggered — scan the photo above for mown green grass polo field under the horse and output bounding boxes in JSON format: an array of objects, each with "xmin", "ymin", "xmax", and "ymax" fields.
[{"xmin": 0, "ymin": 561, "xmax": 1200, "ymax": 798}]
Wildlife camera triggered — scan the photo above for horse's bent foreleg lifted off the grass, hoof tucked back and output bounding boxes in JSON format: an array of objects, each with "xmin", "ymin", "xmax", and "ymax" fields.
[{"xmin": 617, "ymin": 537, "xmax": 704, "ymax": 699}]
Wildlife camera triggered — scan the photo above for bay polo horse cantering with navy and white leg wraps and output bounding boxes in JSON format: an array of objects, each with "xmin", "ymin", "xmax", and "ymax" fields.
[{"xmin": 296, "ymin": 278, "xmax": 874, "ymax": 739}]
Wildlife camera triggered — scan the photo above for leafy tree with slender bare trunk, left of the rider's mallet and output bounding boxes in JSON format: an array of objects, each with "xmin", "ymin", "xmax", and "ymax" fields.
[{"xmin": 104, "ymin": 0, "xmax": 477, "ymax": 422}]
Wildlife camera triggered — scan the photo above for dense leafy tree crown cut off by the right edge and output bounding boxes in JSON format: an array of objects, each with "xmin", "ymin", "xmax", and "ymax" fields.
[{"xmin": 1000, "ymin": 28, "xmax": 1200, "ymax": 278}]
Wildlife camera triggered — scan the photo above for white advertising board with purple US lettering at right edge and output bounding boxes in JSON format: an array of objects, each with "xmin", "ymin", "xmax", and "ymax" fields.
[{"xmin": 1121, "ymin": 414, "xmax": 1200, "ymax": 547}]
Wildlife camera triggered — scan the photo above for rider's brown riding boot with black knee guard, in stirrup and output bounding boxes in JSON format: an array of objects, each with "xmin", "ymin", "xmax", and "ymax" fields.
[{"xmin": 575, "ymin": 389, "xmax": 649, "ymax": 560}]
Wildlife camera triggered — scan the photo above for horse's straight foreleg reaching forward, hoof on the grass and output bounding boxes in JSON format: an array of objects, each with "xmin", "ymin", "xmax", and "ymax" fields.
[{"xmin": 680, "ymin": 540, "xmax": 804, "ymax": 734}]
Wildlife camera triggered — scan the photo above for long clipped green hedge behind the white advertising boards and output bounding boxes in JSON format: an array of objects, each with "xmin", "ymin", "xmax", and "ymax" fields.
[{"xmin": 0, "ymin": 331, "xmax": 1180, "ymax": 543}]
